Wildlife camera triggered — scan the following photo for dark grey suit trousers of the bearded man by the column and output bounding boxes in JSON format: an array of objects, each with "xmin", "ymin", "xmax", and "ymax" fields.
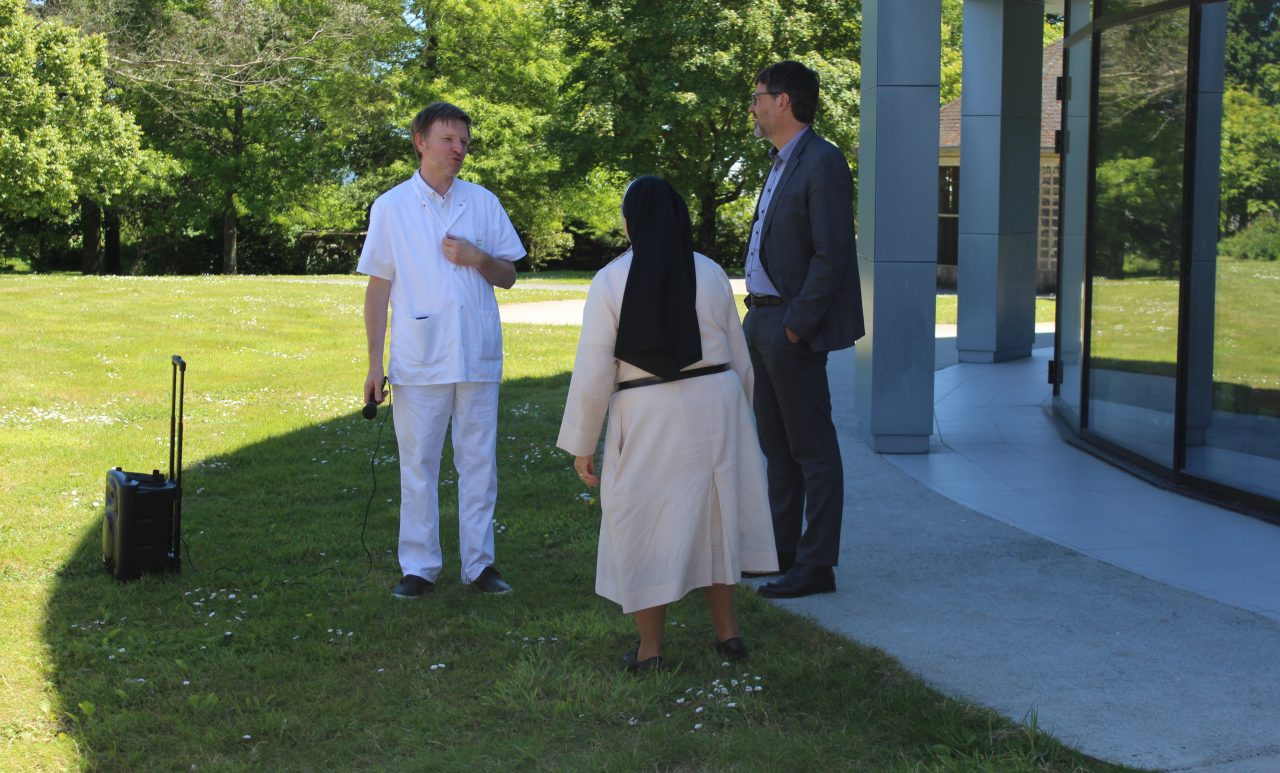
[{"xmin": 742, "ymin": 305, "xmax": 845, "ymax": 567}]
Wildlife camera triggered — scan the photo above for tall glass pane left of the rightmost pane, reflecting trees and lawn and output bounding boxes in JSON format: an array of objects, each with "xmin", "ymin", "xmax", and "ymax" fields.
[{"xmin": 1087, "ymin": 4, "xmax": 1190, "ymax": 468}]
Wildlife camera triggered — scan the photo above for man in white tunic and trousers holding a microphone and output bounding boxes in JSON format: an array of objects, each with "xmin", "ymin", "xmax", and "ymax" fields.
[{"xmin": 356, "ymin": 102, "xmax": 525, "ymax": 599}]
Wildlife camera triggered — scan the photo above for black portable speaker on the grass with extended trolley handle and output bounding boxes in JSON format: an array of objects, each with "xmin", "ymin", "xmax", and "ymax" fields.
[{"xmin": 102, "ymin": 355, "xmax": 187, "ymax": 581}]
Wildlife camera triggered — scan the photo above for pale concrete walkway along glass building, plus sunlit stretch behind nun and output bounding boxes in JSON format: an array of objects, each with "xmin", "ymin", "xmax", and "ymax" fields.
[{"xmin": 502, "ymin": 294, "xmax": 1280, "ymax": 773}]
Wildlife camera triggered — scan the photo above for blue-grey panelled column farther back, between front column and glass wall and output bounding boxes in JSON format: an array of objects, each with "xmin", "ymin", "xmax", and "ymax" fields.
[{"xmin": 956, "ymin": 0, "xmax": 1044, "ymax": 362}]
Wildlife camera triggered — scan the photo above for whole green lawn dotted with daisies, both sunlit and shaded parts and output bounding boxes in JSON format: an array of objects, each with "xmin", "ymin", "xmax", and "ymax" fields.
[{"xmin": 0, "ymin": 276, "xmax": 1141, "ymax": 772}]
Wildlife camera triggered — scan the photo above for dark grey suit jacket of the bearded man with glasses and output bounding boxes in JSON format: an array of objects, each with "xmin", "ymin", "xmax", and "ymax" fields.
[{"xmin": 760, "ymin": 129, "xmax": 865, "ymax": 352}]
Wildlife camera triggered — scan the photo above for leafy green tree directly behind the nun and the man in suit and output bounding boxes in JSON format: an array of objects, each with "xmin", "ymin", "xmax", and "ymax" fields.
[{"xmin": 552, "ymin": 0, "xmax": 860, "ymax": 260}]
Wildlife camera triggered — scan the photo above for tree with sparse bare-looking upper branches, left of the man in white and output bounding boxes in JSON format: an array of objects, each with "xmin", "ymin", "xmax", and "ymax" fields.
[{"xmin": 54, "ymin": 0, "xmax": 401, "ymax": 274}]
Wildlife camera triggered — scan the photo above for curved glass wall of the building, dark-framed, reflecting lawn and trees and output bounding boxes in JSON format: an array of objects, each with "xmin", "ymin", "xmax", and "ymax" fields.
[{"xmin": 1055, "ymin": 0, "xmax": 1280, "ymax": 516}]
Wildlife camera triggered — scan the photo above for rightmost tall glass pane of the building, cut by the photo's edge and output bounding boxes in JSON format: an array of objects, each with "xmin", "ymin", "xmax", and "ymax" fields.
[{"xmin": 1185, "ymin": 1, "xmax": 1280, "ymax": 499}]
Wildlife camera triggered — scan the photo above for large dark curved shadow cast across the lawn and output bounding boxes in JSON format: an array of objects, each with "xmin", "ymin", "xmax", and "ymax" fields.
[{"xmin": 45, "ymin": 374, "xmax": 1131, "ymax": 770}]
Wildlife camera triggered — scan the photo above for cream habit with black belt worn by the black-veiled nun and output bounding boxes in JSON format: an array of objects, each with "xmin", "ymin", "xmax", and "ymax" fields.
[{"xmin": 557, "ymin": 252, "xmax": 777, "ymax": 613}]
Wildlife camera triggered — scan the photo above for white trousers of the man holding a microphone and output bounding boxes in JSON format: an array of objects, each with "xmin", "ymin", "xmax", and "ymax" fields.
[{"xmin": 392, "ymin": 381, "xmax": 498, "ymax": 582}]
